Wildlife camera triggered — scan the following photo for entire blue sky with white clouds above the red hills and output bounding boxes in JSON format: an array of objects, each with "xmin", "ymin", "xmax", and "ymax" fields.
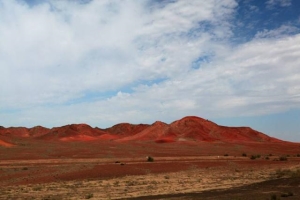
[{"xmin": 0, "ymin": 0, "xmax": 300, "ymax": 142}]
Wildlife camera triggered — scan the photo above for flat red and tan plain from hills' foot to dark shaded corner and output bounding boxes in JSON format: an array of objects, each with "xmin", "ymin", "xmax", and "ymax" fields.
[{"xmin": 0, "ymin": 138, "xmax": 300, "ymax": 199}]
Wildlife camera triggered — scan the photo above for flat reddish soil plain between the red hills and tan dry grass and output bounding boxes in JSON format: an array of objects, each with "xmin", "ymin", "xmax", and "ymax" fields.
[{"xmin": 0, "ymin": 138, "xmax": 300, "ymax": 187}]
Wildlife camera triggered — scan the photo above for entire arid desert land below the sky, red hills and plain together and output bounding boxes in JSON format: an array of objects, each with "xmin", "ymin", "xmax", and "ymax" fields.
[{"xmin": 0, "ymin": 117, "xmax": 300, "ymax": 199}]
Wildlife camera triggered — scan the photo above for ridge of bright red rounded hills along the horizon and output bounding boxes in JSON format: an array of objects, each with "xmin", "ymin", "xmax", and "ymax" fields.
[{"xmin": 0, "ymin": 116, "xmax": 283, "ymax": 147}]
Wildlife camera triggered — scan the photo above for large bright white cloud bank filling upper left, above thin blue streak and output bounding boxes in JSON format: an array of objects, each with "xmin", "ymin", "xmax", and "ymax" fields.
[{"xmin": 0, "ymin": 0, "xmax": 236, "ymax": 108}]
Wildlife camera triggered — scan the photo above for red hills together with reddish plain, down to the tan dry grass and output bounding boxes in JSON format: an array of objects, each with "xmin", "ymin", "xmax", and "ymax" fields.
[{"xmin": 0, "ymin": 117, "xmax": 300, "ymax": 198}]
